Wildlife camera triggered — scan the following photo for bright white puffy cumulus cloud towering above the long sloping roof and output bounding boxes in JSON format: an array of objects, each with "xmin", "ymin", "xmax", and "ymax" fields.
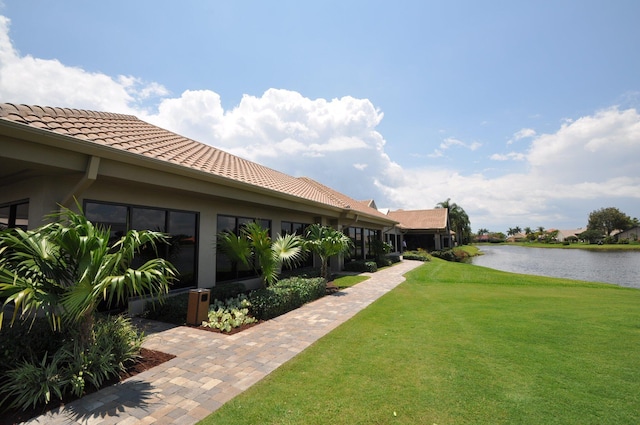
[{"xmin": 145, "ymin": 89, "xmax": 391, "ymax": 198}]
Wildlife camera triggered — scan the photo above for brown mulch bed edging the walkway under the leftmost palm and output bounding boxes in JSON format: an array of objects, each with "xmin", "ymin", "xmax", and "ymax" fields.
[{"xmin": 0, "ymin": 348, "xmax": 175, "ymax": 425}]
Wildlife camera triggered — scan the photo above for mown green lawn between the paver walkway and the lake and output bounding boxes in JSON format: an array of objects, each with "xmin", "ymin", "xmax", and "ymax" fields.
[{"xmin": 201, "ymin": 259, "xmax": 640, "ymax": 425}]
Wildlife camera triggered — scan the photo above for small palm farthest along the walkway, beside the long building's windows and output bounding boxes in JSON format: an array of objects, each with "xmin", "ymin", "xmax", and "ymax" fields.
[{"xmin": 305, "ymin": 224, "xmax": 353, "ymax": 281}]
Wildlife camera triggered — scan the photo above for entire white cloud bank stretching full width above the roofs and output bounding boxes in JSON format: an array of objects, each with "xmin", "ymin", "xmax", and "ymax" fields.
[{"xmin": 0, "ymin": 17, "xmax": 640, "ymax": 230}]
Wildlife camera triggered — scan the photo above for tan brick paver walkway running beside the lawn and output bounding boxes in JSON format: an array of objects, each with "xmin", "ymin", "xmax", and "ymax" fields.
[{"xmin": 28, "ymin": 260, "xmax": 421, "ymax": 425}]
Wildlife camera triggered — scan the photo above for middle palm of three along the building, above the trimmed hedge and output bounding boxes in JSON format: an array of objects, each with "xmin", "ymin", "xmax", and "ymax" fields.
[{"xmin": 217, "ymin": 222, "xmax": 304, "ymax": 287}]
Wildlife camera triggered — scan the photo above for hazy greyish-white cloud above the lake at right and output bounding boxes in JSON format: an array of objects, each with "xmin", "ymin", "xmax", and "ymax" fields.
[{"xmin": 376, "ymin": 108, "xmax": 640, "ymax": 227}]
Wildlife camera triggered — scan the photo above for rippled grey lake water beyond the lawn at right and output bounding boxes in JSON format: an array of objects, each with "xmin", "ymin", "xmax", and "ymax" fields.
[{"xmin": 471, "ymin": 245, "xmax": 640, "ymax": 288}]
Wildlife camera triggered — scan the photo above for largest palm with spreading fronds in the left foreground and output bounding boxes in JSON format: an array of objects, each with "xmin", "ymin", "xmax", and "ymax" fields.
[{"xmin": 0, "ymin": 207, "xmax": 176, "ymax": 347}]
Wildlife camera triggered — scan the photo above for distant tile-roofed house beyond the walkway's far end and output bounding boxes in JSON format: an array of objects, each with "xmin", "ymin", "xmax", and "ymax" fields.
[{"xmin": 386, "ymin": 208, "xmax": 455, "ymax": 251}]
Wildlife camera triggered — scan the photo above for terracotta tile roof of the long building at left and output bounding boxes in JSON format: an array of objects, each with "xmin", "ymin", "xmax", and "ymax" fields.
[{"xmin": 0, "ymin": 103, "xmax": 389, "ymax": 219}]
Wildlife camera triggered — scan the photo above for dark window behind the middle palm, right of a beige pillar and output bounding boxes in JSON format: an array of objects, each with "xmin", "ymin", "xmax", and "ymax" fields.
[{"xmin": 216, "ymin": 215, "xmax": 271, "ymax": 282}]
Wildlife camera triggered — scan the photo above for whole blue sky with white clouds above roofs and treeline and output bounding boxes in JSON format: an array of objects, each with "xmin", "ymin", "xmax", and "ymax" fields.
[{"xmin": 0, "ymin": 0, "xmax": 640, "ymax": 232}]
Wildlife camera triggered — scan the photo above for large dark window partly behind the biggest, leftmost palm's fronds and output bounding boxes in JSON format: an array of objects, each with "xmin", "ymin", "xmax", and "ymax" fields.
[{"xmin": 84, "ymin": 201, "xmax": 198, "ymax": 289}]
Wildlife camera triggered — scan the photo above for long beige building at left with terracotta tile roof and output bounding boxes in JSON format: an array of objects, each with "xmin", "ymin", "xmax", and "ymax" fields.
[{"xmin": 0, "ymin": 103, "xmax": 397, "ymax": 296}]
